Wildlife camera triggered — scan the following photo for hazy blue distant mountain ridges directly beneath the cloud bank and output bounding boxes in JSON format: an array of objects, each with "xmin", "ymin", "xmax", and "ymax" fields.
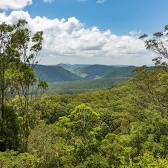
[{"xmin": 34, "ymin": 64, "xmax": 135, "ymax": 82}]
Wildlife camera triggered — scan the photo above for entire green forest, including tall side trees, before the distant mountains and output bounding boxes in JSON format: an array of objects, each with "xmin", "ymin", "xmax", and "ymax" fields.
[{"xmin": 0, "ymin": 20, "xmax": 168, "ymax": 168}]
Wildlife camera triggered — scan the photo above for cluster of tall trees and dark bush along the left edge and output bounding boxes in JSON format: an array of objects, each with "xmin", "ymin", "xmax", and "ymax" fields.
[{"xmin": 0, "ymin": 20, "xmax": 46, "ymax": 151}]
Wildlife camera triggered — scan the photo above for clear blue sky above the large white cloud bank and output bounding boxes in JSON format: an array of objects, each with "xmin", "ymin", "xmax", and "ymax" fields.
[{"xmin": 26, "ymin": 0, "xmax": 168, "ymax": 35}]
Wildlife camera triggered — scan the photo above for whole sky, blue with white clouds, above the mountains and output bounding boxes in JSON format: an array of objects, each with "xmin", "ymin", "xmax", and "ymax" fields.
[{"xmin": 0, "ymin": 0, "xmax": 168, "ymax": 65}]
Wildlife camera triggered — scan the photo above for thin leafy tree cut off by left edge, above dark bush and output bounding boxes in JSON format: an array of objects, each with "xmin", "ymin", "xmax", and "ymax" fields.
[{"xmin": 0, "ymin": 23, "xmax": 15, "ymax": 119}]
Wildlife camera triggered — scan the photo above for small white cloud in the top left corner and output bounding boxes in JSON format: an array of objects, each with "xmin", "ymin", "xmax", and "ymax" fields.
[{"xmin": 0, "ymin": 0, "xmax": 32, "ymax": 9}]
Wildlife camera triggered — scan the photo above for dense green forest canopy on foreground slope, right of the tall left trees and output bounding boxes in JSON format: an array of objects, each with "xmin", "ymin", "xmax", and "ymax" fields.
[{"xmin": 0, "ymin": 68, "xmax": 168, "ymax": 168}]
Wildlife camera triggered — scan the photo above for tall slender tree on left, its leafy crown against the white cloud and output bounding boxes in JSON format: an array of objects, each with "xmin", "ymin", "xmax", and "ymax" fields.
[{"xmin": 12, "ymin": 20, "xmax": 43, "ymax": 151}]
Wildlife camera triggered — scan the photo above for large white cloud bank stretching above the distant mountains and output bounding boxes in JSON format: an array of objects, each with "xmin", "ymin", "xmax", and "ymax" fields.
[{"xmin": 0, "ymin": 11, "xmax": 152, "ymax": 65}]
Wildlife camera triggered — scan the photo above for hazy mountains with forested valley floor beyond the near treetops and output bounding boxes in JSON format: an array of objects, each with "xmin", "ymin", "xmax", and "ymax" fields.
[{"xmin": 34, "ymin": 64, "xmax": 135, "ymax": 93}]
